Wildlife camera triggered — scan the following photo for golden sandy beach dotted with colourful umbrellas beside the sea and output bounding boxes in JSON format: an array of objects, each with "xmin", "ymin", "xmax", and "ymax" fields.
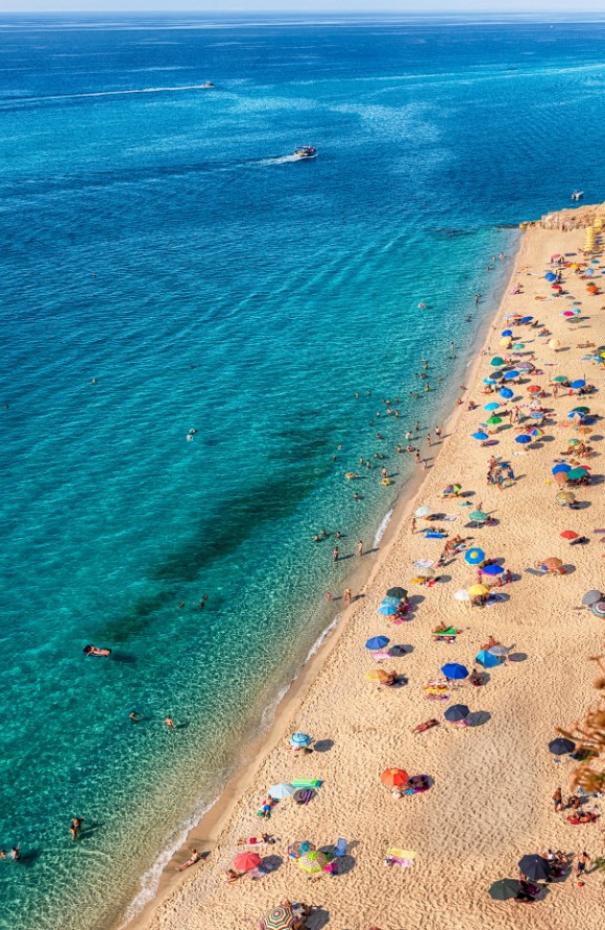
[{"xmin": 131, "ymin": 207, "xmax": 605, "ymax": 930}]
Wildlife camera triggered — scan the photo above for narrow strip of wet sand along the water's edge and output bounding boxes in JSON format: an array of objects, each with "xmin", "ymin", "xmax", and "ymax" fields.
[{"xmin": 117, "ymin": 227, "xmax": 524, "ymax": 930}]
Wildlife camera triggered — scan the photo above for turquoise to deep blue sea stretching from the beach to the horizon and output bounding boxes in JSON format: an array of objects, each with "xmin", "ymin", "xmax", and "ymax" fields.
[{"xmin": 0, "ymin": 18, "xmax": 605, "ymax": 930}]
